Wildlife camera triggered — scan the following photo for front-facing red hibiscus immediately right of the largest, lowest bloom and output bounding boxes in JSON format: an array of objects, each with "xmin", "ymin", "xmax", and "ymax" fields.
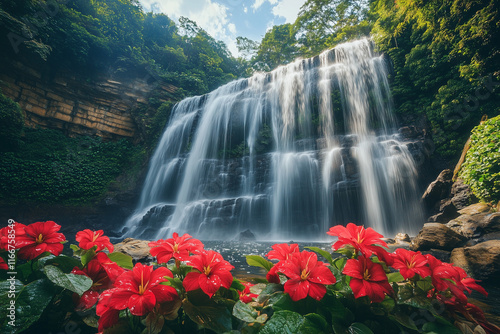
[{"xmin": 182, "ymin": 250, "xmax": 234, "ymax": 298}]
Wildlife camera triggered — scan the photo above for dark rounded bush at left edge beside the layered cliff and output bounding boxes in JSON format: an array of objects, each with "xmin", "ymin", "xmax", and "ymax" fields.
[{"xmin": 0, "ymin": 92, "xmax": 24, "ymax": 152}]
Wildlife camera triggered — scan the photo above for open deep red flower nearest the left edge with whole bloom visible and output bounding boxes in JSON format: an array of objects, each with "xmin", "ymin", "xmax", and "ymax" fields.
[{"xmin": 16, "ymin": 221, "xmax": 66, "ymax": 260}]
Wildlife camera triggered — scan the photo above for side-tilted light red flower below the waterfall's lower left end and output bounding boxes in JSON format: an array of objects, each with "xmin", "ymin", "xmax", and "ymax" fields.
[{"xmin": 148, "ymin": 232, "xmax": 203, "ymax": 263}]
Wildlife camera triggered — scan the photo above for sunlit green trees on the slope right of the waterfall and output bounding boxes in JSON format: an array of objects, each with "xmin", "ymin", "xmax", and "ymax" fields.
[{"xmin": 368, "ymin": 0, "xmax": 500, "ymax": 159}]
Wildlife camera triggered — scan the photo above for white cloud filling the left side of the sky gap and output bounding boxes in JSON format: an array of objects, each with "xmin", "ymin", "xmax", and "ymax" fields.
[{"xmin": 140, "ymin": 0, "xmax": 238, "ymax": 55}]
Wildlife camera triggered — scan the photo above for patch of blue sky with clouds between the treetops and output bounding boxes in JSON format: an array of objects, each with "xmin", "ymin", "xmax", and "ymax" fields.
[{"xmin": 139, "ymin": 0, "xmax": 305, "ymax": 56}]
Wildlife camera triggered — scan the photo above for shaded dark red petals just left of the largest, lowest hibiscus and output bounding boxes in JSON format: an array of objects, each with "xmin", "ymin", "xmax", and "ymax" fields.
[{"xmin": 71, "ymin": 258, "xmax": 111, "ymax": 310}]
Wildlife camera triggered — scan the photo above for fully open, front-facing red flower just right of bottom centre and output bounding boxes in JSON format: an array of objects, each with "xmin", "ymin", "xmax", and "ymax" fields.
[{"xmin": 279, "ymin": 251, "xmax": 336, "ymax": 301}]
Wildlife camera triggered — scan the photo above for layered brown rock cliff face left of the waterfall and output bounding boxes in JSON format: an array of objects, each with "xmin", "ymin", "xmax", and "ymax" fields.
[{"xmin": 0, "ymin": 63, "xmax": 177, "ymax": 139}]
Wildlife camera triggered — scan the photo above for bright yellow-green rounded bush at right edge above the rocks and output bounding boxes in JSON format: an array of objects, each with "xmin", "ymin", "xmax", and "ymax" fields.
[{"xmin": 459, "ymin": 116, "xmax": 500, "ymax": 203}]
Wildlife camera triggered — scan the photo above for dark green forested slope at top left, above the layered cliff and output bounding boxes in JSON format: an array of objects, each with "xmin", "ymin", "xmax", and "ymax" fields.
[{"xmin": 0, "ymin": 0, "xmax": 240, "ymax": 94}]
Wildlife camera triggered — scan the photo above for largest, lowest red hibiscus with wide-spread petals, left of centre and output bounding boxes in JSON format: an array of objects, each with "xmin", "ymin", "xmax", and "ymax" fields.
[{"xmin": 105, "ymin": 263, "xmax": 177, "ymax": 316}]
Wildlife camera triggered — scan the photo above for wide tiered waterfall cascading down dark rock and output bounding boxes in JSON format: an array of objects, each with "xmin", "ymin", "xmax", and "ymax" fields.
[{"xmin": 123, "ymin": 39, "xmax": 422, "ymax": 240}]
